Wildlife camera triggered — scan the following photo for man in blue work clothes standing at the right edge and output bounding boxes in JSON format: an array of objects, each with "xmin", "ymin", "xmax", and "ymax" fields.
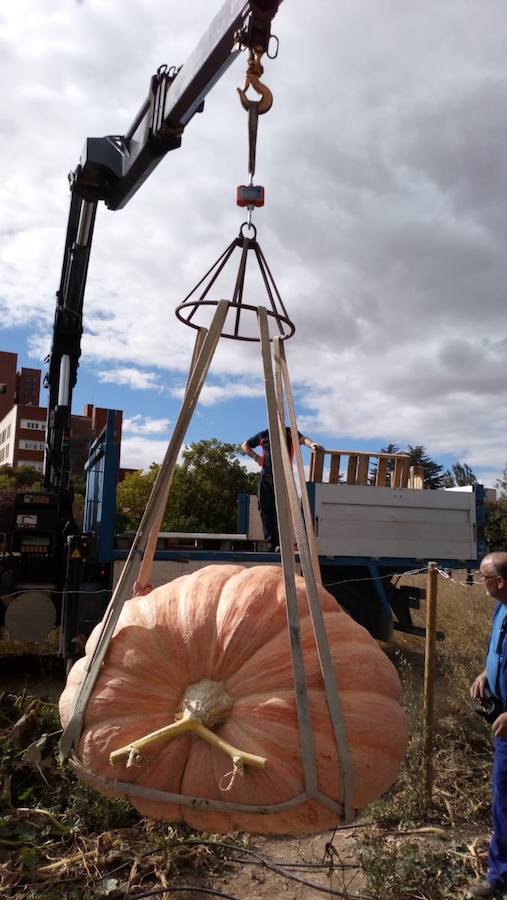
[{"xmin": 469, "ymin": 553, "xmax": 507, "ymax": 898}]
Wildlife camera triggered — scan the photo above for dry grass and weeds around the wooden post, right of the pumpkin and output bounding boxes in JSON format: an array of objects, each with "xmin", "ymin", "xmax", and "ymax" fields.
[{"xmin": 358, "ymin": 573, "xmax": 494, "ymax": 900}]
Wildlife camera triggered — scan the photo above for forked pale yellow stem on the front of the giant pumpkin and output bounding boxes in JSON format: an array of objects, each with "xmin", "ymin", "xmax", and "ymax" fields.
[{"xmin": 109, "ymin": 710, "xmax": 266, "ymax": 770}]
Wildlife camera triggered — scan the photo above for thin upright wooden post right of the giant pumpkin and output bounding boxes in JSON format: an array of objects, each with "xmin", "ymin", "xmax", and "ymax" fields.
[{"xmin": 423, "ymin": 562, "xmax": 438, "ymax": 812}]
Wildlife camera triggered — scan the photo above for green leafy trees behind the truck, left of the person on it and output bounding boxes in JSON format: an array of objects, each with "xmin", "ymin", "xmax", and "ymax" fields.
[{"xmin": 117, "ymin": 438, "xmax": 257, "ymax": 533}]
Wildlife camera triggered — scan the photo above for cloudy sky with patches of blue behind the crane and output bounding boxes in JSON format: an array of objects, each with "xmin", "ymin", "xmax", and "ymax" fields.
[{"xmin": 0, "ymin": 0, "xmax": 507, "ymax": 485}]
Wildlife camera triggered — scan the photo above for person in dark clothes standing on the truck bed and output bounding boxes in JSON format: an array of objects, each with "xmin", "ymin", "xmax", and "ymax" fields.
[{"xmin": 241, "ymin": 427, "xmax": 322, "ymax": 552}]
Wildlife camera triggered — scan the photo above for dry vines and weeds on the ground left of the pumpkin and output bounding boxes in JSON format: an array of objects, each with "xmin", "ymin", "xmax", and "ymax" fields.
[{"xmin": 0, "ymin": 692, "xmax": 239, "ymax": 900}]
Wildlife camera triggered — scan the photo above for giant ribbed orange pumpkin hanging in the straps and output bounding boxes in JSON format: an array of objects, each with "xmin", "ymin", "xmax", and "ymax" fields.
[{"xmin": 60, "ymin": 565, "xmax": 406, "ymax": 834}]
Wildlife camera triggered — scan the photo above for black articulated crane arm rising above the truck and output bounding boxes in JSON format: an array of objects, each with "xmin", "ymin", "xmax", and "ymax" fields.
[{"xmin": 43, "ymin": 0, "xmax": 282, "ymax": 495}]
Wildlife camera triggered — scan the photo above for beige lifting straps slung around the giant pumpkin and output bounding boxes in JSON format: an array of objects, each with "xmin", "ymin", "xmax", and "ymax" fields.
[{"xmin": 60, "ymin": 300, "xmax": 354, "ymax": 821}]
